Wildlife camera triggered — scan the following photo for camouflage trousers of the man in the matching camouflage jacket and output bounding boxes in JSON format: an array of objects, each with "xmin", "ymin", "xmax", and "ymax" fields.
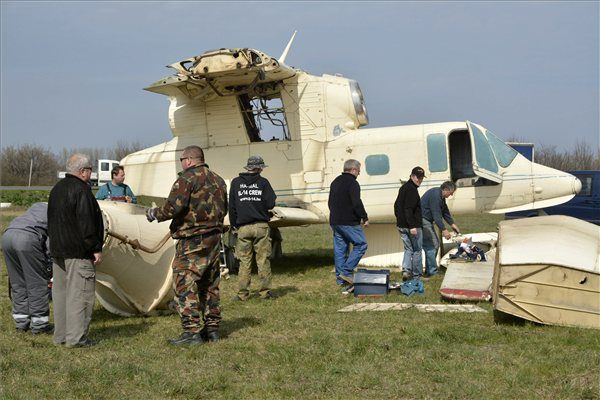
[{"xmin": 172, "ymin": 233, "xmax": 221, "ymax": 333}]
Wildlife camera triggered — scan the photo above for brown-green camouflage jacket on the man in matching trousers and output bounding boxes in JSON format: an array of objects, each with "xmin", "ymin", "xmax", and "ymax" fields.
[{"xmin": 156, "ymin": 164, "xmax": 227, "ymax": 239}]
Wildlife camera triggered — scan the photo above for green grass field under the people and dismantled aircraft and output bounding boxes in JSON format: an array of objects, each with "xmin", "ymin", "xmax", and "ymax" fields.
[{"xmin": 0, "ymin": 209, "xmax": 600, "ymax": 399}]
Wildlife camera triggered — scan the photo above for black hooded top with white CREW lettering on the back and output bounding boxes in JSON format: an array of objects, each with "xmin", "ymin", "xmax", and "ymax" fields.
[{"xmin": 229, "ymin": 172, "xmax": 277, "ymax": 228}]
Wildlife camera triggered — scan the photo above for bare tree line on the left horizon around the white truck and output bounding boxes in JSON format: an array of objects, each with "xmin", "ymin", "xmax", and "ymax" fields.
[{"xmin": 0, "ymin": 141, "xmax": 148, "ymax": 186}]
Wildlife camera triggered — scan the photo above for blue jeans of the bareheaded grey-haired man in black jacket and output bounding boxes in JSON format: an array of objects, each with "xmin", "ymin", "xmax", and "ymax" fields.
[{"xmin": 331, "ymin": 225, "xmax": 367, "ymax": 285}]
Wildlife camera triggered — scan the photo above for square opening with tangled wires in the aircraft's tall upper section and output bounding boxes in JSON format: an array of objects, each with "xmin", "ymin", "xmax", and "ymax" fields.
[{"xmin": 238, "ymin": 93, "xmax": 291, "ymax": 142}]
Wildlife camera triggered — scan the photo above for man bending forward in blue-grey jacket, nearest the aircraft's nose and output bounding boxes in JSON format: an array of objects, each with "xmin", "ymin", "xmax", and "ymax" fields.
[{"xmin": 421, "ymin": 181, "xmax": 460, "ymax": 276}]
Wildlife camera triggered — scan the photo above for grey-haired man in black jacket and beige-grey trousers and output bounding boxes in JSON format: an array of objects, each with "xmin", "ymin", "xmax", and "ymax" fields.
[{"xmin": 48, "ymin": 154, "xmax": 104, "ymax": 347}]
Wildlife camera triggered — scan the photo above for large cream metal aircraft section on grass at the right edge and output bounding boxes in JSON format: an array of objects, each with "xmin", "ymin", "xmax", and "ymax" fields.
[{"xmin": 493, "ymin": 216, "xmax": 600, "ymax": 329}]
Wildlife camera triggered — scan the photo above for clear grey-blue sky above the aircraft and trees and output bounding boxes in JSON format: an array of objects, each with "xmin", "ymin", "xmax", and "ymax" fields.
[{"xmin": 1, "ymin": 0, "xmax": 600, "ymax": 150}]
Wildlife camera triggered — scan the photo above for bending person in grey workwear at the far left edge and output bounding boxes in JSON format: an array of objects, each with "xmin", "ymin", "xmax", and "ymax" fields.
[{"xmin": 2, "ymin": 203, "xmax": 53, "ymax": 335}]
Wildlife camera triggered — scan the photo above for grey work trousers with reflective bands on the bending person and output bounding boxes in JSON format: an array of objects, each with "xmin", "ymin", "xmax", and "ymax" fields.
[{"xmin": 2, "ymin": 229, "xmax": 51, "ymax": 331}]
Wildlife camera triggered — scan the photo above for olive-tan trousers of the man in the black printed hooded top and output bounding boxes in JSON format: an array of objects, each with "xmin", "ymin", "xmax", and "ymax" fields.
[{"xmin": 235, "ymin": 222, "xmax": 271, "ymax": 300}]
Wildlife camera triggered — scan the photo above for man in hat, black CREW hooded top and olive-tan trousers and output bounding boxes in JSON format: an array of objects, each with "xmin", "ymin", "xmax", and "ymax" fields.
[{"xmin": 229, "ymin": 156, "xmax": 277, "ymax": 301}]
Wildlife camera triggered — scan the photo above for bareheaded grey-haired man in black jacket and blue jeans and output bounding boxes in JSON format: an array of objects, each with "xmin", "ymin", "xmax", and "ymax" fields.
[{"xmin": 328, "ymin": 159, "xmax": 369, "ymax": 290}]
